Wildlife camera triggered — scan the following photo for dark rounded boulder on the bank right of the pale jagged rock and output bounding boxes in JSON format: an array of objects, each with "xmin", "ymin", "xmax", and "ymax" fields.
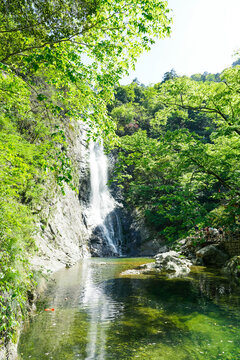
[{"xmin": 196, "ymin": 245, "xmax": 228, "ymax": 267}]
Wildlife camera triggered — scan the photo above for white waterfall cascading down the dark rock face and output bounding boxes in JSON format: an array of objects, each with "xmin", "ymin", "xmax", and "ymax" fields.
[{"xmin": 87, "ymin": 141, "xmax": 122, "ymax": 255}]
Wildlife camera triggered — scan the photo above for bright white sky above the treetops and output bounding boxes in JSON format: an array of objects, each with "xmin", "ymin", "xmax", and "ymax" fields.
[{"xmin": 121, "ymin": 0, "xmax": 240, "ymax": 85}]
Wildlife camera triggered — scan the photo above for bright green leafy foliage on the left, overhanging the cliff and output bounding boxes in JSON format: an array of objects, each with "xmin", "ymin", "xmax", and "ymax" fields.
[{"xmin": 0, "ymin": 0, "xmax": 170, "ymax": 339}]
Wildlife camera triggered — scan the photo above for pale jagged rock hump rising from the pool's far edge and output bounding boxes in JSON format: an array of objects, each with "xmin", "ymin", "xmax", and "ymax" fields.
[{"xmin": 155, "ymin": 251, "xmax": 192, "ymax": 275}]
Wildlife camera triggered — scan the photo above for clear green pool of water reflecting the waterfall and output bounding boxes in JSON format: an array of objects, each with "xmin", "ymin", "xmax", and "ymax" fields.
[{"xmin": 18, "ymin": 258, "xmax": 240, "ymax": 360}]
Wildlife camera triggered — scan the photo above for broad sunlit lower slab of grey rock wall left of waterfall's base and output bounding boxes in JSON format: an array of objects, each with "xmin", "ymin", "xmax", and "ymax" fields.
[{"xmin": 31, "ymin": 187, "xmax": 89, "ymax": 271}]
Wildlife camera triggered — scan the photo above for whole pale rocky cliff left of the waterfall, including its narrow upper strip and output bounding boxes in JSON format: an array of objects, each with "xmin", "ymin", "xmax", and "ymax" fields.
[{"xmin": 31, "ymin": 122, "xmax": 90, "ymax": 271}]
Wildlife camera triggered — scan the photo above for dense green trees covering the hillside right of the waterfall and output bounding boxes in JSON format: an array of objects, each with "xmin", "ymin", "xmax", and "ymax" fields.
[{"xmin": 109, "ymin": 65, "xmax": 240, "ymax": 241}]
